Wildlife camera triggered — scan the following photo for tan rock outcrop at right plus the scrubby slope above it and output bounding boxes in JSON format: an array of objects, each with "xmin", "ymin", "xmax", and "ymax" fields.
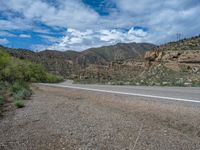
[{"xmin": 144, "ymin": 36, "xmax": 200, "ymax": 72}]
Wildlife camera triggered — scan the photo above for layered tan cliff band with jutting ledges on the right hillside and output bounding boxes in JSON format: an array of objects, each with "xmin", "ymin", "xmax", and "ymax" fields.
[{"xmin": 145, "ymin": 50, "xmax": 200, "ymax": 73}]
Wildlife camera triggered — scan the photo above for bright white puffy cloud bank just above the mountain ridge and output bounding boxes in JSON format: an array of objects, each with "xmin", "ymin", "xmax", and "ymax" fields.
[{"xmin": 49, "ymin": 28, "xmax": 148, "ymax": 50}]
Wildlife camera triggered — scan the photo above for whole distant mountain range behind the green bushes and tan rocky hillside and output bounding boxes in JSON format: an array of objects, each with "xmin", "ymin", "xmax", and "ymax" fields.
[{"xmin": 4, "ymin": 43, "xmax": 156, "ymax": 77}]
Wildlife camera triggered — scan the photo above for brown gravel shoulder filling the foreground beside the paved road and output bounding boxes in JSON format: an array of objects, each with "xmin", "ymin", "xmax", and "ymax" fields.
[{"xmin": 0, "ymin": 84, "xmax": 200, "ymax": 150}]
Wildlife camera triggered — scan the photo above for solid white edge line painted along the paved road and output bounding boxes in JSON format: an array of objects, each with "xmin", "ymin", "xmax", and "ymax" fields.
[{"xmin": 40, "ymin": 83, "xmax": 200, "ymax": 103}]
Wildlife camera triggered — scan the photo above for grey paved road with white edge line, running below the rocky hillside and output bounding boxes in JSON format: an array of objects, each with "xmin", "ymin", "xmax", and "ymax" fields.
[{"xmin": 40, "ymin": 82, "xmax": 200, "ymax": 103}]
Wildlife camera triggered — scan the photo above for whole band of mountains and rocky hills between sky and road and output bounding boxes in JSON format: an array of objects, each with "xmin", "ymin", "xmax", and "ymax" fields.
[{"xmin": 1, "ymin": 36, "xmax": 200, "ymax": 86}]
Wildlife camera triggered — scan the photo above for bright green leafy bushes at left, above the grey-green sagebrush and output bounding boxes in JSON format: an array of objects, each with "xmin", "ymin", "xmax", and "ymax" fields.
[{"xmin": 0, "ymin": 50, "xmax": 63, "ymax": 83}]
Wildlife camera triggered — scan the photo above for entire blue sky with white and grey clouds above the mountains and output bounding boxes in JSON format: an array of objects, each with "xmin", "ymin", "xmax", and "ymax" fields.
[{"xmin": 0, "ymin": 0, "xmax": 200, "ymax": 51}]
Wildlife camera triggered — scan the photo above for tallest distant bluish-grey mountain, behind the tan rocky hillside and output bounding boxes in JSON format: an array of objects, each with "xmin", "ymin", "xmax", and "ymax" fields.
[{"xmin": 76, "ymin": 43, "xmax": 155, "ymax": 65}]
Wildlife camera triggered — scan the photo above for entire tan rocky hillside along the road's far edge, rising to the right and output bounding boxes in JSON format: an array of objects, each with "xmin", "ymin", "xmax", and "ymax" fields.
[{"xmin": 77, "ymin": 36, "xmax": 200, "ymax": 86}]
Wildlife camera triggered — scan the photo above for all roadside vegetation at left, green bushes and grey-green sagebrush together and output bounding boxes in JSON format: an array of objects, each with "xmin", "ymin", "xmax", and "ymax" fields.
[{"xmin": 0, "ymin": 49, "xmax": 63, "ymax": 113}]
